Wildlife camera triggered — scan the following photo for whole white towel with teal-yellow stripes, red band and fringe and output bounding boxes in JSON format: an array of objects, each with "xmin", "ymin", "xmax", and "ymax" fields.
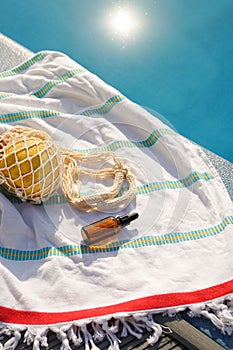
[{"xmin": 0, "ymin": 51, "xmax": 233, "ymax": 349}]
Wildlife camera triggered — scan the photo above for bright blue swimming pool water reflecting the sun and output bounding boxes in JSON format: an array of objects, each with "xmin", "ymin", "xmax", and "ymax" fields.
[{"xmin": 0, "ymin": 0, "xmax": 233, "ymax": 162}]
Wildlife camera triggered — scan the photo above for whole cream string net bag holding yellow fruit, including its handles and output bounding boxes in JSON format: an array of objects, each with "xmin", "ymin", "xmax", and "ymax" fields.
[{"xmin": 0, "ymin": 126, "xmax": 136, "ymax": 211}]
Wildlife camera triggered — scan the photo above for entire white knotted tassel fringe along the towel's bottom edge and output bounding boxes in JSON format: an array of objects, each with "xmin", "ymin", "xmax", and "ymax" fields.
[{"xmin": 0, "ymin": 296, "xmax": 233, "ymax": 350}]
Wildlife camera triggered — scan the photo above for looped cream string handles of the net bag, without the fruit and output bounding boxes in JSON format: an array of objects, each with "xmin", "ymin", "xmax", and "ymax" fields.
[{"xmin": 62, "ymin": 152, "xmax": 136, "ymax": 211}]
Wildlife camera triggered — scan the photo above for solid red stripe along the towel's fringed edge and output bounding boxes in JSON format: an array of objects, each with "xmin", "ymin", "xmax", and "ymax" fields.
[{"xmin": 0, "ymin": 280, "xmax": 233, "ymax": 325}]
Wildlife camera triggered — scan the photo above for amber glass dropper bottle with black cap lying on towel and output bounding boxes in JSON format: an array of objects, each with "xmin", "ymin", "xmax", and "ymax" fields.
[{"xmin": 81, "ymin": 213, "xmax": 139, "ymax": 246}]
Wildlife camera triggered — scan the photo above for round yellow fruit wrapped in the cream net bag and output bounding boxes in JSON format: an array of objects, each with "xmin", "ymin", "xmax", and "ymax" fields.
[{"xmin": 0, "ymin": 131, "xmax": 61, "ymax": 203}]
